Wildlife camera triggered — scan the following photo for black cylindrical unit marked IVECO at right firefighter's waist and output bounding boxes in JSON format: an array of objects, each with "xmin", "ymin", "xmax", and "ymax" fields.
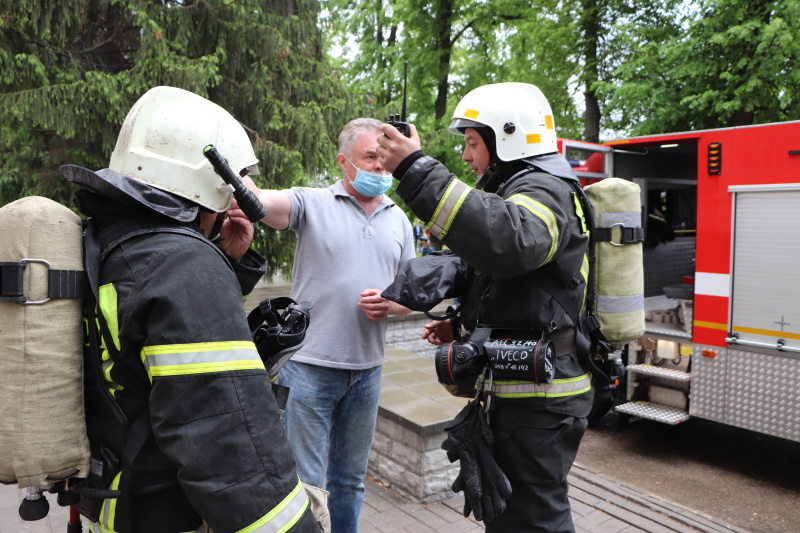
[{"xmin": 434, "ymin": 327, "xmax": 556, "ymax": 398}]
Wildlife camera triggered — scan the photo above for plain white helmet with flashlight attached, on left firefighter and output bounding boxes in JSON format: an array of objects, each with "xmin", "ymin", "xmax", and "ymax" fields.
[{"xmin": 108, "ymin": 87, "xmax": 258, "ymax": 213}]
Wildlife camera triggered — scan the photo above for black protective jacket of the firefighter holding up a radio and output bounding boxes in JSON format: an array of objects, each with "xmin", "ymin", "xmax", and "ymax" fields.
[{"xmin": 395, "ymin": 152, "xmax": 592, "ymax": 416}]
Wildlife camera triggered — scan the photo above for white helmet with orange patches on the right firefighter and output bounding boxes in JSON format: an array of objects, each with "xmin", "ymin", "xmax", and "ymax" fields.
[{"xmin": 449, "ymin": 83, "xmax": 557, "ymax": 161}]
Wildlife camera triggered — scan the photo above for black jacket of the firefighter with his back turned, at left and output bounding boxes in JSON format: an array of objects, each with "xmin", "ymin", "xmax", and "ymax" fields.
[{"xmin": 71, "ymin": 178, "xmax": 318, "ymax": 533}]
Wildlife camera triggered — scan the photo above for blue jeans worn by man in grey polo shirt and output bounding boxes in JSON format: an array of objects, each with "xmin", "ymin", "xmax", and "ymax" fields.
[{"xmin": 280, "ymin": 361, "xmax": 381, "ymax": 533}]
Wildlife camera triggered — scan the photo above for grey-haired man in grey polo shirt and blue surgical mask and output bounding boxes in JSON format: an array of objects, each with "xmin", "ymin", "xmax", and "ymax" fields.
[{"xmin": 250, "ymin": 118, "xmax": 415, "ymax": 533}]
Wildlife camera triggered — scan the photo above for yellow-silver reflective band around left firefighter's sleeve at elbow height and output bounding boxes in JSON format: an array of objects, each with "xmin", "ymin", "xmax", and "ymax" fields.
[{"xmin": 141, "ymin": 341, "xmax": 264, "ymax": 381}]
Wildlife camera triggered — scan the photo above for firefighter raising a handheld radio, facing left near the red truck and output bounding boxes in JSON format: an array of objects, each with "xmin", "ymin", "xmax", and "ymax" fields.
[{"xmin": 378, "ymin": 83, "xmax": 593, "ymax": 532}]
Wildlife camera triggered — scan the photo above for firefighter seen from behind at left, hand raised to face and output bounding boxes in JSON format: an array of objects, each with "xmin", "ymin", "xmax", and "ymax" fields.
[{"xmin": 63, "ymin": 87, "xmax": 319, "ymax": 533}]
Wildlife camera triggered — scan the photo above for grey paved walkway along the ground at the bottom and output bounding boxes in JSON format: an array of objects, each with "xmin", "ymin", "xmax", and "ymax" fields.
[{"xmin": 0, "ymin": 464, "xmax": 747, "ymax": 533}]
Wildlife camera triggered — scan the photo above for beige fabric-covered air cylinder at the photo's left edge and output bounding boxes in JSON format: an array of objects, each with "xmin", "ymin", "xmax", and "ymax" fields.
[{"xmin": 0, "ymin": 196, "xmax": 90, "ymax": 490}]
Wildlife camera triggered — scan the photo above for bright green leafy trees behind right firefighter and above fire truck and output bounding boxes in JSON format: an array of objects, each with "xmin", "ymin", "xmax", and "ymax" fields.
[{"xmin": 321, "ymin": 0, "xmax": 800, "ymax": 145}]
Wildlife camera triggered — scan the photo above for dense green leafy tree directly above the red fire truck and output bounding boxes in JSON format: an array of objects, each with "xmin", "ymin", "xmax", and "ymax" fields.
[{"xmin": 604, "ymin": 0, "xmax": 800, "ymax": 135}]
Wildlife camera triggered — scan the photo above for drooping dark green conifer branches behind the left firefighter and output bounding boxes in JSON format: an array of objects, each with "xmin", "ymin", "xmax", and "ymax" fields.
[{"xmin": 0, "ymin": 0, "xmax": 353, "ymax": 274}]
